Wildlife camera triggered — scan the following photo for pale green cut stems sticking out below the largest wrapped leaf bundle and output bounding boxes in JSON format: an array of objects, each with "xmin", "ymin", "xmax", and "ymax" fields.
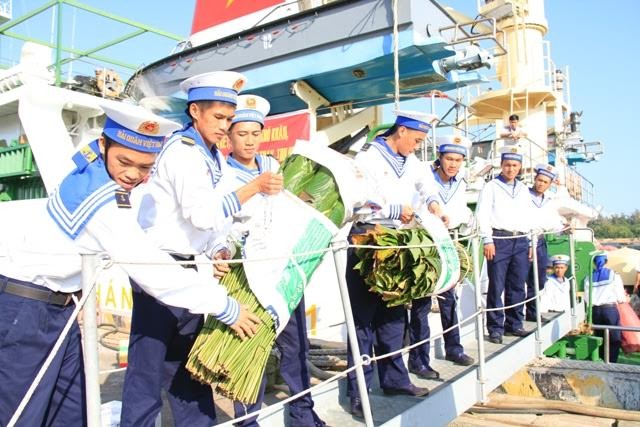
[{"xmin": 186, "ymin": 265, "xmax": 276, "ymax": 404}]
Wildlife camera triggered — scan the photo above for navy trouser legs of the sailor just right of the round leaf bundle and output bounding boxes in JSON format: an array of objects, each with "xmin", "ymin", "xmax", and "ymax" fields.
[{"xmin": 409, "ymin": 288, "xmax": 464, "ymax": 369}]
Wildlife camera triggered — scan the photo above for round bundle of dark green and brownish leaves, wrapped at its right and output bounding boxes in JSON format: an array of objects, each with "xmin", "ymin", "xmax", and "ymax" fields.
[{"xmin": 352, "ymin": 225, "xmax": 471, "ymax": 307}]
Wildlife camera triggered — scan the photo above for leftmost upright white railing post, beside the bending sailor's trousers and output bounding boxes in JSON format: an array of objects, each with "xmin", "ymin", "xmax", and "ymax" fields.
[{"xmin": 82, "ymin": 254, "xmax": 101, "ymax": 427}]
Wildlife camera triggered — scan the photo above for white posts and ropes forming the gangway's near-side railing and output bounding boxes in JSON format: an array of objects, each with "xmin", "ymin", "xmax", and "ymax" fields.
[{"xmin": 8, "ymin": 224, "xmax": 575, "ymax": 427}]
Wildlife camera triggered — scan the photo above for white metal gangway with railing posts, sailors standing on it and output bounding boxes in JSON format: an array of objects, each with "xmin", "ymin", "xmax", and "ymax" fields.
[{"xmin": 8, "ymin": 226, "xmax": 584, "ymax": 427}]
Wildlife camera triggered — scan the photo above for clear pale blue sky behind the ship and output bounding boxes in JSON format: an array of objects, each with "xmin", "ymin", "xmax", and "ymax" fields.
[{"xmin": 0, "ymin": 0, "xmax": 640, "ymax": 215}]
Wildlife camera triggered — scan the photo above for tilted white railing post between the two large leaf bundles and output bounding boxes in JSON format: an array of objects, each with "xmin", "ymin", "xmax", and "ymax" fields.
[{"xmin": 331, "ymin": 240, "xmax": 373, "ymax": 427}]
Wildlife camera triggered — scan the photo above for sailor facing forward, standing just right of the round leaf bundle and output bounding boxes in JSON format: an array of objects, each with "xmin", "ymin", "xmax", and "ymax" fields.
[{"xmin": 409, "ymin": 135, "xmax": 473, "ymax": 379}]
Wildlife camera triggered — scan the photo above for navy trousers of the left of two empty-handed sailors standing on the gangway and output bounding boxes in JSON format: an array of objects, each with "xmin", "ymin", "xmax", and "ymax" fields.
[{"xmin": 487, "ymin": 236, "xmax": 529, "ymax": 335}]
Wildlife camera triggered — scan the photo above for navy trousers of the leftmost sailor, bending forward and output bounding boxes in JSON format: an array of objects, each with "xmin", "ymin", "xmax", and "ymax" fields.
[{"xmin": 0, "ymin": 280, "xmax": 87, "ymax": 427}]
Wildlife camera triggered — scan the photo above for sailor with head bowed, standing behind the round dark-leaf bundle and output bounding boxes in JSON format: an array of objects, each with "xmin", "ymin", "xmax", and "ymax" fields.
[{"xmin": 346, "ymin": 111, "xmax": 443, "ymax": 417}]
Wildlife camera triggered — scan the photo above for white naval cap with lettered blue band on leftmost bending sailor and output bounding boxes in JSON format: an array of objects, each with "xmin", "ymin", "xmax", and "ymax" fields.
[{"xmin": 101, "ymin": 103, "xmax": 182, "ymax": 153}]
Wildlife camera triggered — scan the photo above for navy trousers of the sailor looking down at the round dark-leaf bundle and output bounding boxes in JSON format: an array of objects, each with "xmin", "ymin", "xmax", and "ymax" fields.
[{"xmin": 346, "ymin": 251, "xmax": 411, "ymax": 397}]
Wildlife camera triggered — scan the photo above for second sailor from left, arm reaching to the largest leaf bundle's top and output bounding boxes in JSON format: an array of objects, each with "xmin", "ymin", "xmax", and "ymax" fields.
[{"xmin": 121, "ymin": 71, "xmax": 282, "ymax": 427}]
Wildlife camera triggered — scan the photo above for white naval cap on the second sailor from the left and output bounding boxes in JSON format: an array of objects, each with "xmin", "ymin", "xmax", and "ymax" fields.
[{"xmin": 180, "ymin": 71, "xmax": 247, "ymax": 105}]
